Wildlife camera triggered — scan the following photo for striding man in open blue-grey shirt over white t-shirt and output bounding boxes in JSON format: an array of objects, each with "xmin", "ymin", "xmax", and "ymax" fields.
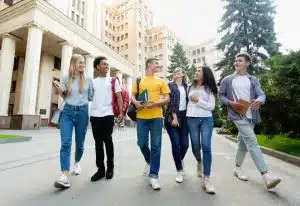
[{"xmin": 219, "ymin": 53, "xmax": 281, "ymax": 189}]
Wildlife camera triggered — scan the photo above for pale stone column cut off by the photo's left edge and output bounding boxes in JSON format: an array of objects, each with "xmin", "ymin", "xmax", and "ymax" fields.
[{"xmin": 0, "ymin": 34, "xmax": 16, "ymax": 116}]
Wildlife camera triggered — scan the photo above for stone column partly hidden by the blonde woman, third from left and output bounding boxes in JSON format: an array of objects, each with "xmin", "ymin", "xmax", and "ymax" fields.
[{"xmin": 60, "ymin": 41, "xmax": 73, "ymax": 79}]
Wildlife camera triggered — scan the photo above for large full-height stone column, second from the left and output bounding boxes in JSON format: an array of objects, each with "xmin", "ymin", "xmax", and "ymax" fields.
[{"xmin": 19, "ymin": 24, "xmax": 43, "ymax": 115}]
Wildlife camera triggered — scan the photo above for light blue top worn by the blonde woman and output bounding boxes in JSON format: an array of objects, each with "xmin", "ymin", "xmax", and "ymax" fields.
[{"xmin": 61, "ymin": 77, "xmax": 94, "ymax": 106}]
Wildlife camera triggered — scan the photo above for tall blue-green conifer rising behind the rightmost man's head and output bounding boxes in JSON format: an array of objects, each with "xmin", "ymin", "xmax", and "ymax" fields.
[{"xmin": 216, "ymin": 0, "xmax": 280, "ymax": 79}]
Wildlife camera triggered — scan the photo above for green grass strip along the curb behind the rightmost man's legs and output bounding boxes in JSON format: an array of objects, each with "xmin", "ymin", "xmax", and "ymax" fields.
[{"xmin": 233, "ymin": 135, "xmax": 300, "ymax": 157}]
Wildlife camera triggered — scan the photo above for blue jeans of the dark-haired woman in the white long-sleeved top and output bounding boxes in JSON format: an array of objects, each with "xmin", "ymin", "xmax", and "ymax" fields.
[{"xmin": 187, "ymin": 117, "xmax": 213, "ymax": 176}]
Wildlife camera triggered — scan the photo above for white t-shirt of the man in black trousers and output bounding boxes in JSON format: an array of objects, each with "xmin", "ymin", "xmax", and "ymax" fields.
[{"xmin": 91, "ymin": 77, "xmax": 122, "ymax": 117}]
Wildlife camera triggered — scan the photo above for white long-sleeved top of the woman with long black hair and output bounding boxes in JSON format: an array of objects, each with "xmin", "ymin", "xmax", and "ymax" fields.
[{"xmin": 186, "ymin": 87, "xmax": 216, "ymax": 117}]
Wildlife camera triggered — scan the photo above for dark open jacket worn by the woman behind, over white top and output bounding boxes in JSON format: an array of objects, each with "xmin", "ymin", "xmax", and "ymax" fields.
[{"xmin": 168, "ymin": 82, "xmax": 188, "ymax": 114}]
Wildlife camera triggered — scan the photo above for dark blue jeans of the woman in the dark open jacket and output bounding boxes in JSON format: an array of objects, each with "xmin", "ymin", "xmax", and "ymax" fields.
[{"xmin": 165, "ymin": 111, "xmax": 189, "ymax": 171}]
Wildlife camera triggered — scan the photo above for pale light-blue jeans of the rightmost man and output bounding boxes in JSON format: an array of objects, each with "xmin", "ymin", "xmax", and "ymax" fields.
[{"xmin": 234, "ymin": 118, "xmax": 268, "ymax": 172}]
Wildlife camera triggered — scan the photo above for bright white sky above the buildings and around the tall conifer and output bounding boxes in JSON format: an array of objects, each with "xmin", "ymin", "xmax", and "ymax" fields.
[{"xmin": 103, "ymin": 0, "xmax": 300, "ymax": 52}]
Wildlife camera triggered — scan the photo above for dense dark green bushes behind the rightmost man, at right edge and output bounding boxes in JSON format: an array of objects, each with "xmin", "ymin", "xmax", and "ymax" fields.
[{"xmin": 260, "ymin": 51, "xmax": 300, "ymax": 137}]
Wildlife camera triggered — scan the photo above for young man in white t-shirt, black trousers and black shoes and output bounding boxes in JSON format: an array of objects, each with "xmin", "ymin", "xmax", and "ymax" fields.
[{"xmin": 90, "ymin": 56, "xmax": 124, "ymax": 182}]
